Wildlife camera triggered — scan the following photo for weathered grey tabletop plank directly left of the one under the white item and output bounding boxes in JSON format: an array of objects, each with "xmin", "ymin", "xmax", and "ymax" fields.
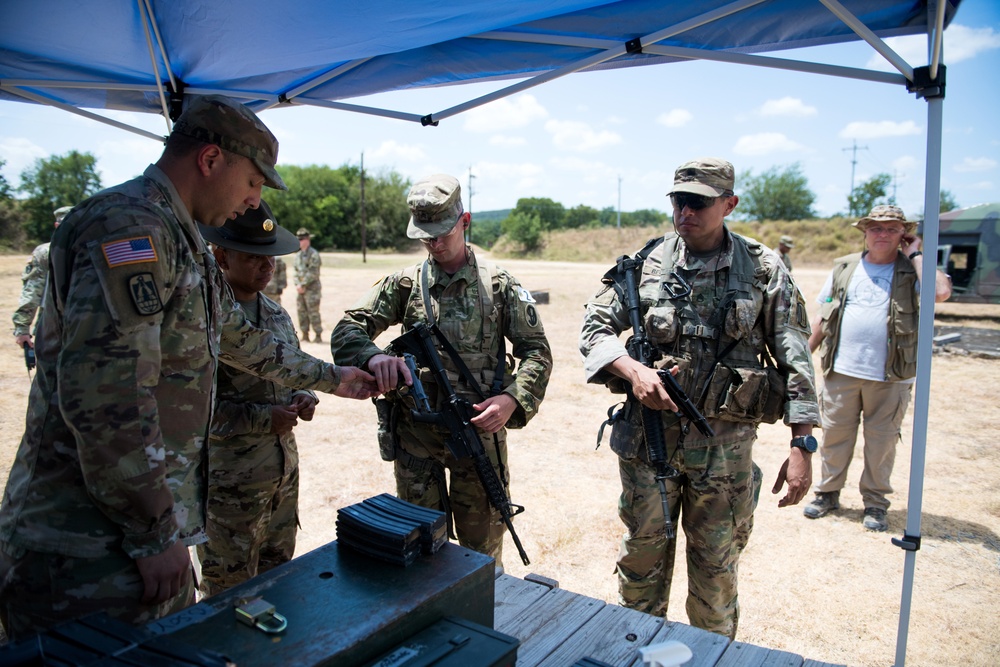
[{"xmin": 539, "ymin": 604, "xmax": 664, "ymax": 667}]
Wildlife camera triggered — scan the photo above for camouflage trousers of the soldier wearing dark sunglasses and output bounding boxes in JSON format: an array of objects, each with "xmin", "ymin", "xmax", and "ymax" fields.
[{"xmin": 617, "ymin": 440, "xmax": 761, "ymax": 639}]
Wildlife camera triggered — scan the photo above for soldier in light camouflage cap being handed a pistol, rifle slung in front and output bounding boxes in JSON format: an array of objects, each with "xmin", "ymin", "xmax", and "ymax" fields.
[{"xmin": 330, "ymin": 174, "xmax": 552, "ymax": 567}]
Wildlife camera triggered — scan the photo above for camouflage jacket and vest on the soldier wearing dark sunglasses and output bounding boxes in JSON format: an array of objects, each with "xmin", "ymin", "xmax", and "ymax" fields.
[{"xmin": 580, "ymin": 229, "xmax": 819, "ymax": 446}]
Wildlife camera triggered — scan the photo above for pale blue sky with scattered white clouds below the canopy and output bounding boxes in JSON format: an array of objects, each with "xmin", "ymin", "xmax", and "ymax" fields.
[{"xmin": 0, "ymin": 0, "xmax": 1000, "ymax": 217}]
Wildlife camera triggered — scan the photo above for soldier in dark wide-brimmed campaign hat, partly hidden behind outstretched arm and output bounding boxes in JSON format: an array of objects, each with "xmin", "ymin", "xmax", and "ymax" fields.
[{"xmin": 198, "ymin": 200, "xmax": 318, "ymax": 595}]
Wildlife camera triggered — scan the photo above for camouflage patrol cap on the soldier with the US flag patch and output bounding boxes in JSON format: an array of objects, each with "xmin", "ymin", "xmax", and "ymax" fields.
[{"xmin": 173, "ymin": 95, "xmax": 288, "ymax": 190}]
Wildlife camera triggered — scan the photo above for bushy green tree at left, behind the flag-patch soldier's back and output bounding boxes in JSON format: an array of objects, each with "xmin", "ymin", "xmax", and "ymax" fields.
[{"xmin": 19, "ymin": 151, "xmax": 101, "ymax": 241}]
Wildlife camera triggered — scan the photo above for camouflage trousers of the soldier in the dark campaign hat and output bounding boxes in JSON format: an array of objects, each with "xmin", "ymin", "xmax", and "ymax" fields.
[{"xmin": 198, "ymin": 447, "xmax": 299, "ymax": 596}]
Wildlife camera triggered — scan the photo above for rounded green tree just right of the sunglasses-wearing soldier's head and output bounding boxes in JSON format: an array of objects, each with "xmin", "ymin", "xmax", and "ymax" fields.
[{"xmin": 736, "ymin": 162, "xmax": 816, "ymax": 222}]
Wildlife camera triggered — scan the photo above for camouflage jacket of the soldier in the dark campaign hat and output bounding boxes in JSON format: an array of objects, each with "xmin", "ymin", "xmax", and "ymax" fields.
[{"xmin": 209, "ymin": 295, "xmax": 308, "ymax": 478}]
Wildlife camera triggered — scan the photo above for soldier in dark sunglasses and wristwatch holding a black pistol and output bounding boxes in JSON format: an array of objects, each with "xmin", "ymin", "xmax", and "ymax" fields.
[{"xmin": 580, "ymin": 158, "xmax": 819, "ymax": 638}]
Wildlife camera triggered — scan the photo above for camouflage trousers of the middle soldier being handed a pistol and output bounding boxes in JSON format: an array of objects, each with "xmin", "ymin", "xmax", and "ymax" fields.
[{"xmin": 394, "ymin": 424, "xmax": 510, "ymax": 567}]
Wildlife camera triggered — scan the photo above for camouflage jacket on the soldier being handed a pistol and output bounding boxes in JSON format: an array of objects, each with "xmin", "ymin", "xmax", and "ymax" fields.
[{"xmin": 330, "ymin": 250, "xmax": 552, "ymax": 426}]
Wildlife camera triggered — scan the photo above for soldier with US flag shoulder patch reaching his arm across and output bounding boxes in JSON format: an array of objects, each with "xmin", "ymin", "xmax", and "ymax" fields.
[{"xmin": 0, "ymin": 96, "xmax": 375, "ymax": 639}]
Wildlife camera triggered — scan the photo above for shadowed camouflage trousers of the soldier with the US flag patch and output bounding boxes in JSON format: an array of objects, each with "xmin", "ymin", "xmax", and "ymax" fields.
[{"xmin": 0, "ymin": 546, "xmax": 194, "ymax": 641}]
